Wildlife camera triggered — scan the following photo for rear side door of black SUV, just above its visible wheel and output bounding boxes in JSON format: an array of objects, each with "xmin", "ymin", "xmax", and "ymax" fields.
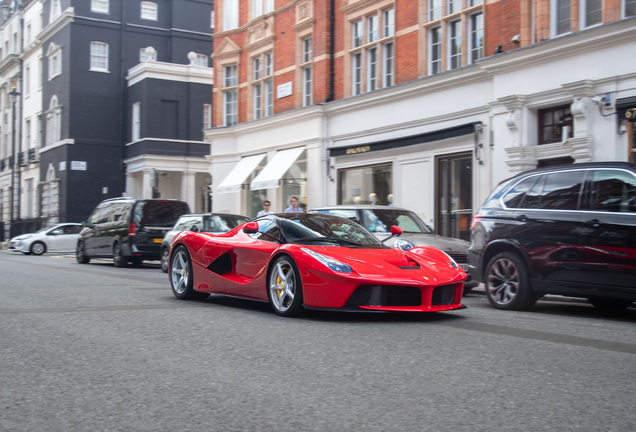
[{"xmin": 509, "ymin": 170, "xmax": 585, "ymax": 292}]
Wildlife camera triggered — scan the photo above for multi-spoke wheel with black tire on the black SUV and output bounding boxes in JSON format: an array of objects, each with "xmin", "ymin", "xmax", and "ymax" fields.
[{"xmin": 484, "ymin": 252, "xmax": 538, "ymax": 311}]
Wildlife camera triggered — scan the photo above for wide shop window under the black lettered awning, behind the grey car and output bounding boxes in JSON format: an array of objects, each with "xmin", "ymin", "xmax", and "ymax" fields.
[{"xmin": 338, "ymin": 163, "xmax": 393, "ymax": 205}]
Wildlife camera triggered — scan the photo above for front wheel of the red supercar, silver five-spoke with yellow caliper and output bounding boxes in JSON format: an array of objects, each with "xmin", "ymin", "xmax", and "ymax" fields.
[{"xmin": 267, "ymin": 255, "xmax": 303, "ymax": 317}]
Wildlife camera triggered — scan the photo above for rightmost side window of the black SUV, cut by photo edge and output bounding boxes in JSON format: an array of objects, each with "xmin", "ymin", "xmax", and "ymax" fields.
[{"xmin": 586, "ymin": 170, "xmax": 636, "ymax": 212}]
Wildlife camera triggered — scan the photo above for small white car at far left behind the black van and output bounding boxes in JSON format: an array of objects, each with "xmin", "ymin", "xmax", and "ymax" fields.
[{"xmin": 9, "ymin": 223, "xmax": 82, "ymax": 255}]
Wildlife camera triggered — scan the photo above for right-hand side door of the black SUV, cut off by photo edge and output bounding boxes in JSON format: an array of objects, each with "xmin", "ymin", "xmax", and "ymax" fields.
[{"xmin": 580, "ymin": 169, "xmax": 636, "ymax": 295}]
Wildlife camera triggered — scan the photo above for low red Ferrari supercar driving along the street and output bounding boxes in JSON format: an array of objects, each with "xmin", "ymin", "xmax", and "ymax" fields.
[{"xmin": 169, "ymin": 213, "xmax": 466, "ymax": 316}]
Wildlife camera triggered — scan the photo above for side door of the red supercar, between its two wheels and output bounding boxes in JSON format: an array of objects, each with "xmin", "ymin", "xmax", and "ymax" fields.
[{"xmin": 224, "ymin": 219, "xmax": 281, "ymax": 300}]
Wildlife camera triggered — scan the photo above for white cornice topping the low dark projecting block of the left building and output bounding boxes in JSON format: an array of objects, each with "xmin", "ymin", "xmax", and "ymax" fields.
[{"xmin": 126, "ymin": 61, "xmax": 214, "ymax": 87}]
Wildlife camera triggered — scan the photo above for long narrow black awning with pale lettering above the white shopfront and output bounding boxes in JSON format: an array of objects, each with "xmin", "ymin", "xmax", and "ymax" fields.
[{"xmin": 329, "ymin": 122, "xmax": 481, "ymax": 157}]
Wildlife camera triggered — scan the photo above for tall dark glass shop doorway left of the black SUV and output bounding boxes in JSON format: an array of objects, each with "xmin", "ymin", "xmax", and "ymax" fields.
[{"xmin": 435, "ymin": 152, "xmax": 473, "ymax": 241}]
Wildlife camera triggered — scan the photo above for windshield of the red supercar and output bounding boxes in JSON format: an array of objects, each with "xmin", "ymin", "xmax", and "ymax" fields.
[{"xmin": 281, "ymin": 213, "xmax": 385, "ymax": 248}]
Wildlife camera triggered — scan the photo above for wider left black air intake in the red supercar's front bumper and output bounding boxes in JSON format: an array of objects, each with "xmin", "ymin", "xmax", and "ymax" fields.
[{"xmin": 347, "ymin": 285, "xmax": 422, "ymax": 306}]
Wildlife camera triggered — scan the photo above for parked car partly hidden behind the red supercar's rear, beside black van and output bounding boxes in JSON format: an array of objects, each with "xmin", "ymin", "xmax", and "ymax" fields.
[{"xmin": 161, "ymin": 213, "xmax": 249, "ymax": 273}]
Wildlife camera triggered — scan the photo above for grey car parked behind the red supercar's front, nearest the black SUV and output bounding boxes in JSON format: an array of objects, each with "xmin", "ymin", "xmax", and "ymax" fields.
[{"xmin": 310, "ymin": 205, "xmax": 478, "ymax": 293}]
